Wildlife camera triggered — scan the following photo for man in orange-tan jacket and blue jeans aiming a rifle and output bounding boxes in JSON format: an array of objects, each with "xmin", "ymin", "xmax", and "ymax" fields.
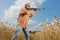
[{"xmin": 11, "ymin": 3, "xmax": 37, "ymax": 40}]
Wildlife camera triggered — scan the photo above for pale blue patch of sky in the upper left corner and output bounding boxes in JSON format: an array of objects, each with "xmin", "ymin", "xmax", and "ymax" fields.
[{"xmin": 0, "ymin": 0, "xmax": 15, "ymax": 17}]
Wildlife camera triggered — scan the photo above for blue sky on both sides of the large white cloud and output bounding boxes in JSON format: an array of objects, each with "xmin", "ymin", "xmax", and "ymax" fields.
[{"xmin": 0, "ymin": 0, "xmax": 60, "ymax": 23}]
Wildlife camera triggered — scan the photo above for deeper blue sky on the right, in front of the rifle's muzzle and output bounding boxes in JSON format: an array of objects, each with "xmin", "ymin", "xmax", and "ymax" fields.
[{"xmin": 33, "ymin": 0, "xmax": 60, "ymax": 22}]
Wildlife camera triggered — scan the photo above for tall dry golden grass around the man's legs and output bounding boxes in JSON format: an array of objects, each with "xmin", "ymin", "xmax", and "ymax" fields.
[{"xmin": 0, "ymin": 19, "xmax": 60, "ymax": 40}]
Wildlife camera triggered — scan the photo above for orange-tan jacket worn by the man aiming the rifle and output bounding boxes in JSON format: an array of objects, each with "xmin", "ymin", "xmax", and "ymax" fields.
[{"xmin": 17, "ymin": 8, "xmax": 34, "ymax": 28}]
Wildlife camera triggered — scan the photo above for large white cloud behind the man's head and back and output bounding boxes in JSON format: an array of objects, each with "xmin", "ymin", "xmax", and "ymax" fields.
[{"xmin": 4, "ymin": 0, "xmax": 45, "ymax": 23}]
